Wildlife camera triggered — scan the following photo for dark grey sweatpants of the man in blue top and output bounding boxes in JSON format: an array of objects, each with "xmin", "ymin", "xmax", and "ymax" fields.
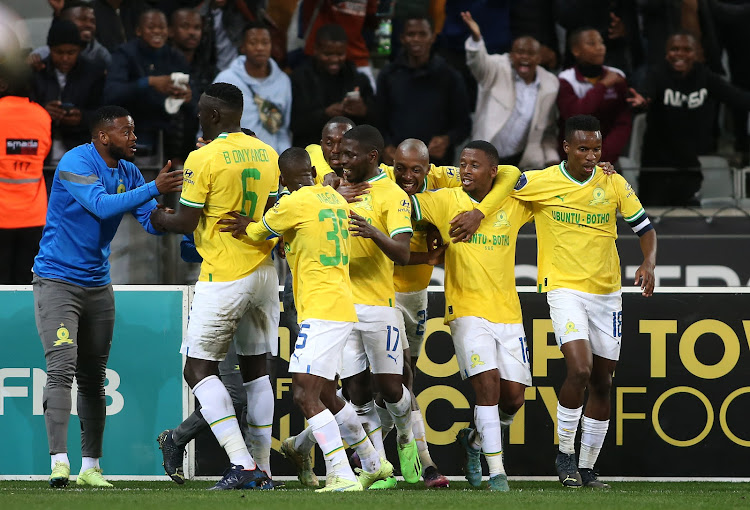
[{"xmin": 32, "ymin": 275, "xmax": 115, "ymax": 458}]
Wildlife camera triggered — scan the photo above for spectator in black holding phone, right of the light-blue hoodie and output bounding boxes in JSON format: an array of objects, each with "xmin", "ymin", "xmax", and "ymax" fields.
[{"xmin": 291, "ymin": 24, "xmax": 374, "ymax": 147}]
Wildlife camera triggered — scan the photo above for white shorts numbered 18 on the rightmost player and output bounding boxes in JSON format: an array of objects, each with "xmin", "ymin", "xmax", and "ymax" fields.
[{"xmin": 547, "ymin": 289, "xmax": 622, "ymax": 361}]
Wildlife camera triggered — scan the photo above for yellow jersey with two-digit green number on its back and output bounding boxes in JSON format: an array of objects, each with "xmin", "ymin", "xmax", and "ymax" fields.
[{"xmin": 246, "ymin": 184, "xmax": 357, "ymax": 322}]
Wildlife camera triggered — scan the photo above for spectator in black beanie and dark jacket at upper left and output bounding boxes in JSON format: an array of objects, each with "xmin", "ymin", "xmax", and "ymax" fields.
[{"xmin": 31, "ymin": 18, "xmax": 105, "ymax": 161}]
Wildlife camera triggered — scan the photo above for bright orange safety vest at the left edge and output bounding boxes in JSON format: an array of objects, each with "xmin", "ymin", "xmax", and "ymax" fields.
[{"xmin": 0, "ymin": 96, "xmax": 52, "ymax": 228}]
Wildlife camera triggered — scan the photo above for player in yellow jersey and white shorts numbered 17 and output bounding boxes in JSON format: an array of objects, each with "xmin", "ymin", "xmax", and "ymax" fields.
[{"xmin": 341, "ymin": 125, "xmax": 422, "ymax": 483}]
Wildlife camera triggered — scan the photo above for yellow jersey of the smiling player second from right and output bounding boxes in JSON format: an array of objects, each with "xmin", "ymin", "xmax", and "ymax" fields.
[{"xmin": 412, "ymin": 188, "xmax": 532, "ymax": 324}]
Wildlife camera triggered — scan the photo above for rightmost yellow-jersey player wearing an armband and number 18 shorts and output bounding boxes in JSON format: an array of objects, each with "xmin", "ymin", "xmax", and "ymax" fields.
[{"xmin": 513, "ymin": 115, "xmax": 656, "ymax": 488}]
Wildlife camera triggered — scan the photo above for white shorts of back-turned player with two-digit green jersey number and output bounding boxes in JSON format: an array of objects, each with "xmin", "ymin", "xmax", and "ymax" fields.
[{"xmin": 289, "ymin": 319, "xmax": 355, "ymax": 381}]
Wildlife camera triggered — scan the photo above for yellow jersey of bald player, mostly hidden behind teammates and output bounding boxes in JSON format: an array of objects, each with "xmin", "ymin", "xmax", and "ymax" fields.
[{"xmin": 380, "ymin": 164, "xmax": 518, "ymax": 292}]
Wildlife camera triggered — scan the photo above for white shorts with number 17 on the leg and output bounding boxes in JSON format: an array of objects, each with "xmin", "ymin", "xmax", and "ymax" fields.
[{"xmin": 339, "ymin": 305, "xmax": 404, "ymax": 379}]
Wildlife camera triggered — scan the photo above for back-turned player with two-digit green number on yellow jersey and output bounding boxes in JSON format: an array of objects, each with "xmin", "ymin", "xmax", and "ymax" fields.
[{"xmin": 222, "ymin": 147, "xmax": 393, "ymax": 491}]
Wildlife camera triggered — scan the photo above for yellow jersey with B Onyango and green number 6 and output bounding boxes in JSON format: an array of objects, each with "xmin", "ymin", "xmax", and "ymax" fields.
[{"xmin": 180, "ymin": 133, "xmax": 279, "ymax": 282}]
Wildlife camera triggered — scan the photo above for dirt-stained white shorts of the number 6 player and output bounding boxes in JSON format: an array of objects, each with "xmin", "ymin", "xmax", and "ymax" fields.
[{"xmin": 180, "ymin": 257, "xmax": 280, "ymax": 361}]
